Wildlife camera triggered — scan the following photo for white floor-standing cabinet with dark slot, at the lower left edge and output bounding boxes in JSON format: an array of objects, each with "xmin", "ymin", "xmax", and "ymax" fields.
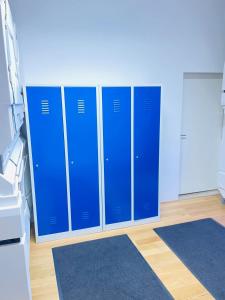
[{"xmin": 0, "ymin": 139, "xmax": 31, "ymax": 300}]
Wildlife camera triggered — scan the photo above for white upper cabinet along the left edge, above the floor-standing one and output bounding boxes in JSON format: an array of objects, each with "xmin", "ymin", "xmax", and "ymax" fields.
[{"xmin": 0, "ymin": 0, "xmax": 24, "ymax": 172}]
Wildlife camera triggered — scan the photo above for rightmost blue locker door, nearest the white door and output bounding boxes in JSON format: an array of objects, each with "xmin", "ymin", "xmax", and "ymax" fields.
[{"xmin": 134, "ymin": 87, "xmax": 161, "ymax": 220}]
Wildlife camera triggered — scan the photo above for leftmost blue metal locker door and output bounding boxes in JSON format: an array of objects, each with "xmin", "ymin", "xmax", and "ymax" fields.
[{"xmin": 27, "ymin": 87, "xmax": 69, "ymax": 236}]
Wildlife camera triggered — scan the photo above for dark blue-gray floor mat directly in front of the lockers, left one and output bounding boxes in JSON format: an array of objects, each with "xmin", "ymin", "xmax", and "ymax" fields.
[{"xmin": 52, "ymin": 235, "xmax": 173, "ymax": 300}]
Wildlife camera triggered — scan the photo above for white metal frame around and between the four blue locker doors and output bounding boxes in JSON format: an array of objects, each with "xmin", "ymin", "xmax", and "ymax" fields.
[{"xmin": 25, "ymin": 85, "xmax": 161, "ymax": 242}]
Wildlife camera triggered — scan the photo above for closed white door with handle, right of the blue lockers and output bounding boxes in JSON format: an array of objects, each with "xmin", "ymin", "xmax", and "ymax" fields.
[{"xmin": 180, "ymin": 73, "xmax": 223, "ymax": 194}]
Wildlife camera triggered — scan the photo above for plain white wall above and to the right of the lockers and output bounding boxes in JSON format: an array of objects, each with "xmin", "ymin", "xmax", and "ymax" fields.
[{"xmin": 11, "ymin": 0, "xmax": 225, "ymax": 200}]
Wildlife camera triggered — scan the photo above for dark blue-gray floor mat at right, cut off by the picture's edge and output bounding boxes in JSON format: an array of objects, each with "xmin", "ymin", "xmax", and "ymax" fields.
[{"xmin": 154, "ymin": 219, "xmax": 225, "ymax": 300}]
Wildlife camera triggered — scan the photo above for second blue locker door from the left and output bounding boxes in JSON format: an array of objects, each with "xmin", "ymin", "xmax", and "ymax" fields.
[{"xmin": 65, "ymin": 87, "xmax": 100, "ymax": 230}]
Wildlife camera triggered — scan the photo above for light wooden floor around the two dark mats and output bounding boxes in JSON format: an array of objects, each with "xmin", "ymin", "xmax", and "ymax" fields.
[{"xmin": 30, "ymin": 196, "xmax": 225, "ymax": 300}]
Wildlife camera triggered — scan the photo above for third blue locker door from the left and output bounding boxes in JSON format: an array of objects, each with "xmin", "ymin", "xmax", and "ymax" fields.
[{"xmin": 102, "ymin": 87, "xmax": 131, "ymax": 224}]
